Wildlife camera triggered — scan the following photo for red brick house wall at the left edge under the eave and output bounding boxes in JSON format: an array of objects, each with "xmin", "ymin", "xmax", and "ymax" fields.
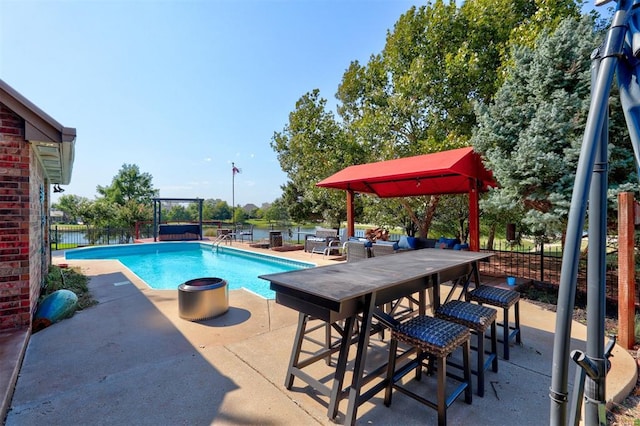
[{"xmin": 0, "ymin": 104, "xmax": 41, "ymax": 330}]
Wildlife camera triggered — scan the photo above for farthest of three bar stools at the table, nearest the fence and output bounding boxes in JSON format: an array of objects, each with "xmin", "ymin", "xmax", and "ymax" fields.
[{"xmin": 467, "ymin": 285, "xmax": 522, "ymax": 360}]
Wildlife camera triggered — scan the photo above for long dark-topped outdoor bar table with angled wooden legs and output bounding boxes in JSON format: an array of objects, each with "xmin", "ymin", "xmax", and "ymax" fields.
[{"xmin": 260, "ymin": 249, "xmax": 493, "ymax": 424}]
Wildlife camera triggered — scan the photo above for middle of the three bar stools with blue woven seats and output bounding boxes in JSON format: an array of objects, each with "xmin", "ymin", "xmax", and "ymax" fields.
[{"xmin": 436, "ymin": 300, "xmax": 498, "ymax": 397}]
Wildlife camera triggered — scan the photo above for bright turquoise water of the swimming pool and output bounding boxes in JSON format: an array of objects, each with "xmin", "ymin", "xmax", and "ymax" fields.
[{"xmin": 65, "ymin": 242, "xmax": 315, "ymax": 299}]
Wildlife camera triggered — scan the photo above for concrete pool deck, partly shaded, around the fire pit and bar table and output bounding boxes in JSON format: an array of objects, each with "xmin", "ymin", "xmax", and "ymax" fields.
[{"xmin": 0, "ymin": 243, "xmax": 636, "ymax": 425}]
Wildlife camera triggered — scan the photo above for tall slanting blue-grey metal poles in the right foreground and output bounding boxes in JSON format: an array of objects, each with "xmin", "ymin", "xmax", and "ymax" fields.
[{"xmin": 549, "ymin": 0, "xmax": 637, "ymax": 425}]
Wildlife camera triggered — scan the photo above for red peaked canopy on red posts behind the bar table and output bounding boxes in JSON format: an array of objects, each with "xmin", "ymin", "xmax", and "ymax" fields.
[{"xmin": 316, "ymin": 147, "xmax": 496, "ymax": 251}]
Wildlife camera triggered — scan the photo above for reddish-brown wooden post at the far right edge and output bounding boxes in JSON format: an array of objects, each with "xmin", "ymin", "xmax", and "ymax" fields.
[{"xmin": 618, "ymin": 192, "xmax": 636, "ymax": 349}]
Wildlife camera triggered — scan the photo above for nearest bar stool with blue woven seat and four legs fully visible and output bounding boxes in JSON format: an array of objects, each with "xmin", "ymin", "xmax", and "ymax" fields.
[{"xmin": 384, "ymin": 316, "xmax": 473, "ymax": 425}]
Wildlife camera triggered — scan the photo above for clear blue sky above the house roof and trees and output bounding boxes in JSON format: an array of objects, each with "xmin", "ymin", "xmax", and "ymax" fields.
[{"xmin": 0, "ymin": 0, "xmax": 425, "ymax": 206}]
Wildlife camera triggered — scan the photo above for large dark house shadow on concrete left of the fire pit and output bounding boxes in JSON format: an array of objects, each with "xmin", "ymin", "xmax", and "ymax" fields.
[{"xmin": 6, "ymin": 273, "xmax": 242, "ymax": 425}]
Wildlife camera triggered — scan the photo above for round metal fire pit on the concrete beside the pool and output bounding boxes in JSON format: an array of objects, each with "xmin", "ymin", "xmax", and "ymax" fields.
[{"xmin": 178, "ymin": 278, "xmax": 229, "ymax": 321}]
